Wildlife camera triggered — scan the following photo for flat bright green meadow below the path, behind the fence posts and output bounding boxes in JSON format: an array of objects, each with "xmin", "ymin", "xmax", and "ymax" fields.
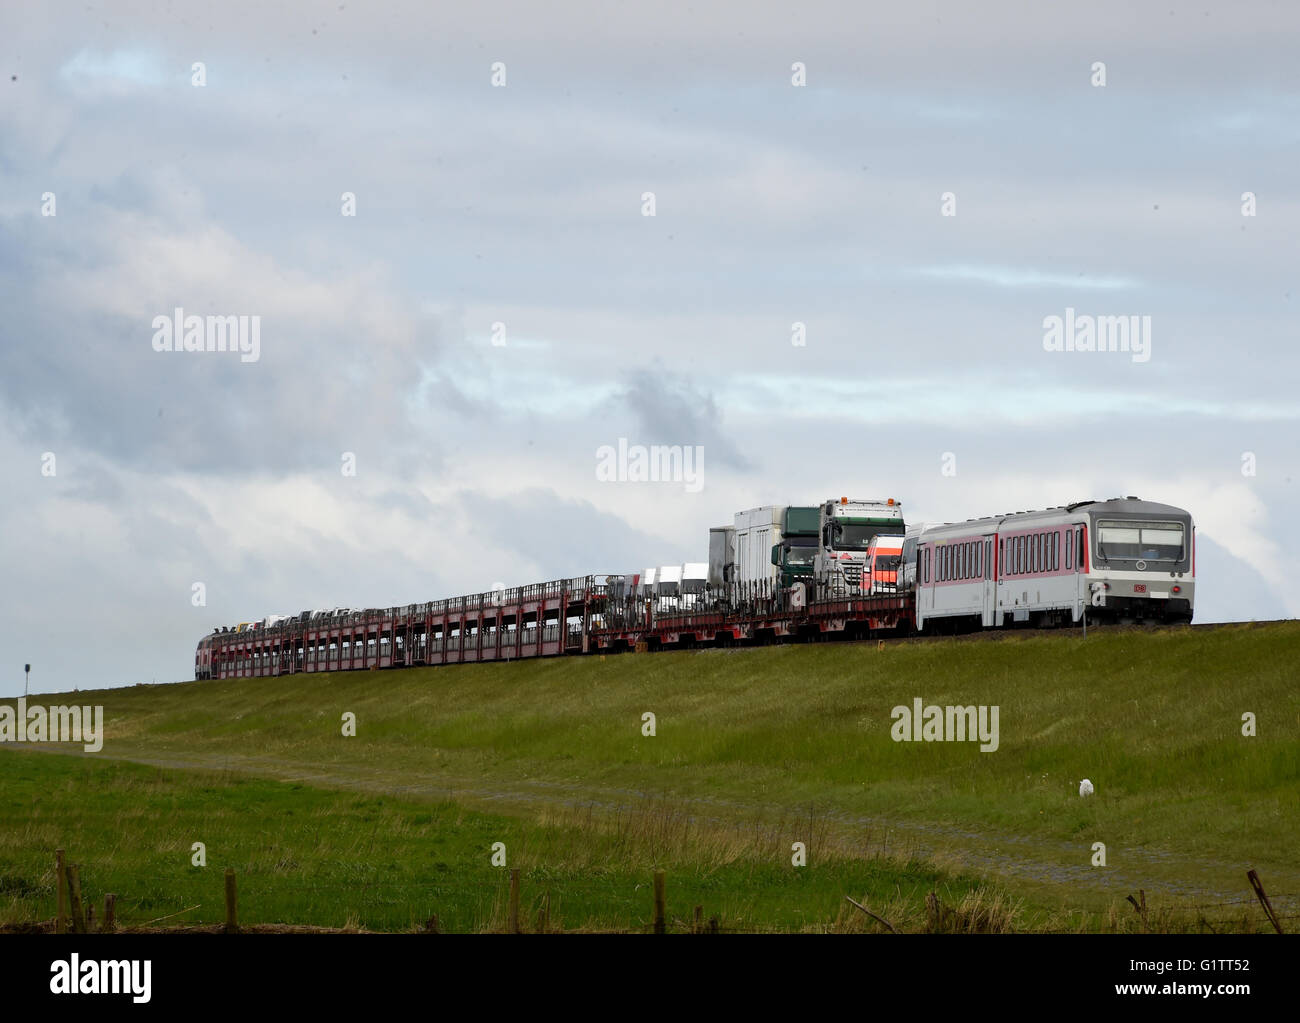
[{"xmin": 0, "ymin": 753, "xmax": 1011, "ymax": 932}]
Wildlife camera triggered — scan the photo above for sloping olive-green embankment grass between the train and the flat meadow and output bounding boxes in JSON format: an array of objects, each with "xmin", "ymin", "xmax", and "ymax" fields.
[{"xmin": 0, "ymin": 623, "xmax": 1300, "ymax": 927}]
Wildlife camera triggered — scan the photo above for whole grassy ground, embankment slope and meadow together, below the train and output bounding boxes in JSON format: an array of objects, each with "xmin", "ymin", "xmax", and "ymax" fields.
[{"xmin": 0, "ymin": 623, "xmax": 1300, "ymax": 929}]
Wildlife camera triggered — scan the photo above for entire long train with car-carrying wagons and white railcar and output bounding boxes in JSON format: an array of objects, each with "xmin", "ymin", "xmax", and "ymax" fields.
[{"xmin": 195, "ymin": 497, "xmax": 1196, "ymax": 680}]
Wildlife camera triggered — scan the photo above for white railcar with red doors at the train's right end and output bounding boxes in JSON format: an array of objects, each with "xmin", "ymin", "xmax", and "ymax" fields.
[{"xmin": 915, "ymin": 498, "xmax": 1196, "ymax": 632}]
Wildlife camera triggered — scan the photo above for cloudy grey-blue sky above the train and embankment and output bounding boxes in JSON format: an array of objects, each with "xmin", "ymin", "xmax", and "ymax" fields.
[{"xmin": 0, "ymin": 0, "xmax": 1300, "ymax": 695}]
